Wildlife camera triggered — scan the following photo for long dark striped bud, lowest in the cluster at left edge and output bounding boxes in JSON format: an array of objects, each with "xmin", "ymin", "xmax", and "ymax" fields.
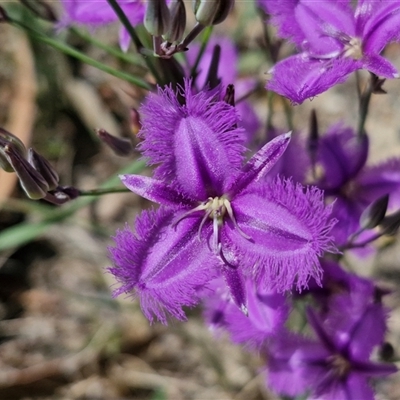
[{"xmin": 3, "ymin": 144, "xmax": 49, "ymax": 200}]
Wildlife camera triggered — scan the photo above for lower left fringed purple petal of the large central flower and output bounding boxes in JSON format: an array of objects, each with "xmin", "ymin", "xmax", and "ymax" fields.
[{"xmin": 109, "ymin": 208, "xmax": 219, "ymax": 324}]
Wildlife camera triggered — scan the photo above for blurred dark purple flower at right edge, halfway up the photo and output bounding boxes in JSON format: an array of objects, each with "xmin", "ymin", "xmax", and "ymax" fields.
[{"xmin": 316, "ymin": 125, "xmax": 400, "ymax": 244}]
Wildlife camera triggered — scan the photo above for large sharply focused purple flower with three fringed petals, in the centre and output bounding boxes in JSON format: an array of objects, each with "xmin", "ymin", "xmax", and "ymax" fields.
[{"xmin": 111, "ymin": 82, "xmax": 335, "ymax": 319}]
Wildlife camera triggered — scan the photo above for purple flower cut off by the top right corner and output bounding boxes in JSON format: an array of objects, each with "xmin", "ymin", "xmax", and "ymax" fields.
[{"xmin": 260, "ymin": 0, "xmax": 400, "ymax": 103}]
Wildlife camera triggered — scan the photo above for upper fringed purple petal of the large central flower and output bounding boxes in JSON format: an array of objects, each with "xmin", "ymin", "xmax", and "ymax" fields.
[{"xmin": 140, "ymin": 81, "xmax": 245, "ymax": 200}]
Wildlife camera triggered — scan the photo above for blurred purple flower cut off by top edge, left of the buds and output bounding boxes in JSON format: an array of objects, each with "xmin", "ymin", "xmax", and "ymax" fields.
[{"xmin": 59, "ymin": 0, "xmax": 145, "ymax": 51}]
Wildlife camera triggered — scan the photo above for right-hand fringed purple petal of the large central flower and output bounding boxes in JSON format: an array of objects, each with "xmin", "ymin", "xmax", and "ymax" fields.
[{"xmin": 221, "ymin": 179, "xmax": 336, "ymax": 292}]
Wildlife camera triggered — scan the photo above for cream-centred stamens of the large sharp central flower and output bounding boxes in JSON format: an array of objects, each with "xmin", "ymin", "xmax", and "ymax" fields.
[{"xmin": 175, "ymin": 195, "xmax": 250, "ymax": 254}]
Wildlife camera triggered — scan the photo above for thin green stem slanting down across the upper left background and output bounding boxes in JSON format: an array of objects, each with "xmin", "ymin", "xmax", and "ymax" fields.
[{"xmin": 10, "ymin": 20, "xmax": 152, "ymax": 90}]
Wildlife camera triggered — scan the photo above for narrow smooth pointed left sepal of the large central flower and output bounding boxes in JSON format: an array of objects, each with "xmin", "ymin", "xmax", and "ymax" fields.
[{"xmin": 120, "ymin": 175, "xmax": 193, "ymax": 207}]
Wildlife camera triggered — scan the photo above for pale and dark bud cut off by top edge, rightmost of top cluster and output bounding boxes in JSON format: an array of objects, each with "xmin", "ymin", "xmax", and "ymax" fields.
[{"xmin": 193, "ymin": 0, "xmax": 235, "ymax": 26}]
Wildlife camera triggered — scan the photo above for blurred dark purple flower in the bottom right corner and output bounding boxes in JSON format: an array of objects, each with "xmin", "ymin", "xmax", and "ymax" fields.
[{"xmin": 268, "ymin": 306, "xmax": 397, "ymax": 400}]
